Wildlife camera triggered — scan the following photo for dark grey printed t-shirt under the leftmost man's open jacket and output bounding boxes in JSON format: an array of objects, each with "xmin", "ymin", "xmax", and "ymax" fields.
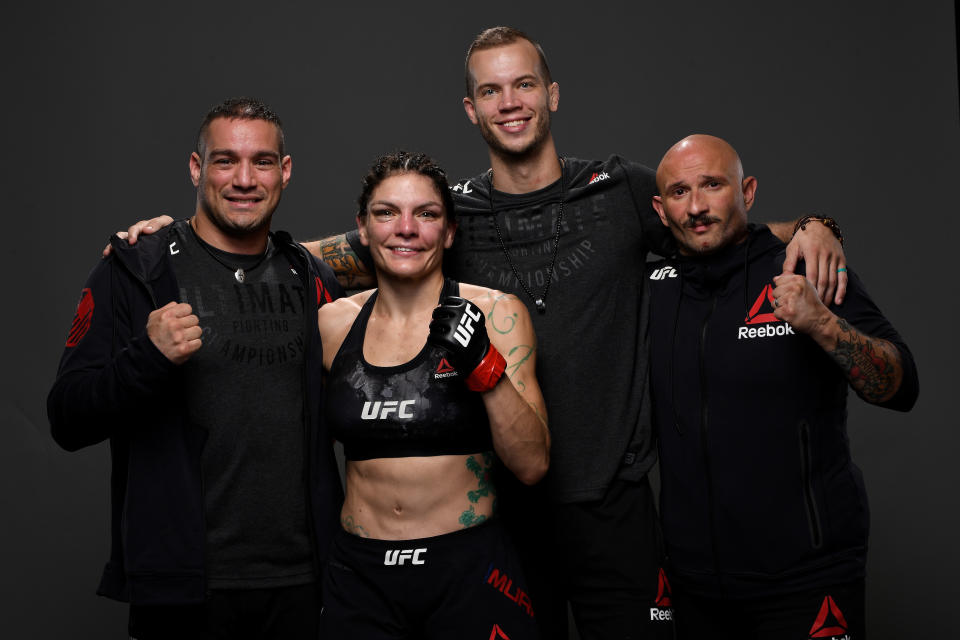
[{"xmin": 170, "ymin": 222, "xmax": 314, "ymax": 588}]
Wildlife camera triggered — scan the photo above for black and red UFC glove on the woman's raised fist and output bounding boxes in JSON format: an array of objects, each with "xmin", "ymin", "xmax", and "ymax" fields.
[{"xmin": 427, "ymin": 296, "xmax": 507, "ymax": 392}]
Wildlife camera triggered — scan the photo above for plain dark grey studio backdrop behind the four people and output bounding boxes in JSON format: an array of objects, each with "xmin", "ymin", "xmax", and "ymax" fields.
[{"xmin": 0, "ymin": 0, "xmax": 960, "ymax": 638}]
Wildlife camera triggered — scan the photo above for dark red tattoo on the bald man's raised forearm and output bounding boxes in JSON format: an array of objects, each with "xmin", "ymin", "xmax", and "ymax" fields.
[{"xmin": 830, "ymin": 318, "xmax": 897, "ymax": 402}]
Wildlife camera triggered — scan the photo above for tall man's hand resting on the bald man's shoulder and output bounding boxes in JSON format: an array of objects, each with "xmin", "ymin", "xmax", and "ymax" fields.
[{"xmin": 771, "ymin": 220, "xmax": 847, "ymax": 304}]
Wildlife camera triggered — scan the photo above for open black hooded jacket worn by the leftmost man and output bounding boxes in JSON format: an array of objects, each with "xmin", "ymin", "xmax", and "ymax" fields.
[{"xmin": 47, "ymin": 227, "xmax": 343, "ymax": 604}]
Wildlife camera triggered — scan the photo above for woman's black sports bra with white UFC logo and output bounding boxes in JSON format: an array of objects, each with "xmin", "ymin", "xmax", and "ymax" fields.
[{"xmin": 324, "ymin": 278, "xmax": 493, "ymax": 460}]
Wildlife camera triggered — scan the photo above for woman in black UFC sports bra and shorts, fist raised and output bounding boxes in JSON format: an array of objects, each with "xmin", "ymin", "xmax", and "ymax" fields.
[{"xmin": 319, "ymin": 152, "xmax": 550, "ymax": 640}]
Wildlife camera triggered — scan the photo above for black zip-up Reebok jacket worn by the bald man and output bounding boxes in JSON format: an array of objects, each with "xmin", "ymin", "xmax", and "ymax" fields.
[{"xmin": 648, "ymin": 225, "xmax": 918, "ymax": 598}]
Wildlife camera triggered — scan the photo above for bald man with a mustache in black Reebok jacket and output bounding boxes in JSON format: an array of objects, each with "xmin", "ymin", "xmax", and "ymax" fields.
[{"xmin": 648, "ymin": 135, "xmax": 918, "ymax": 640}]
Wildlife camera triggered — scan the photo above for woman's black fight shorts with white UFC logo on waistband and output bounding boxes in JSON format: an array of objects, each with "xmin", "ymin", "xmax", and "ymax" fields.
[{"xmin": 321, "ymin": 520, "xmax": 539, "ymax": 640}]
